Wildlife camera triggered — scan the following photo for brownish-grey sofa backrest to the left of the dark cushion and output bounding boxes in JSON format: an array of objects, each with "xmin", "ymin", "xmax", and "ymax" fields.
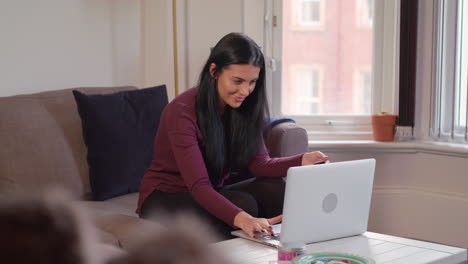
[{"xmin": 0, "ymin": 86, "xmax": 136, "ymax": 197}]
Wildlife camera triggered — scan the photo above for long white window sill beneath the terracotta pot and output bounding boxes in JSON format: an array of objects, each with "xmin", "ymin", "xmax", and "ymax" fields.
[{"xmin": 309, "ymin": 140, "xmax": 468, "ymax": 157}]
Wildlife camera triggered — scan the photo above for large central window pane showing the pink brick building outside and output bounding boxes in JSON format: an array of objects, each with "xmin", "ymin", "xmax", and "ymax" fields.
[{"xmin": 281, "ymin": 0, "xmax": 373, "ymax": 115}]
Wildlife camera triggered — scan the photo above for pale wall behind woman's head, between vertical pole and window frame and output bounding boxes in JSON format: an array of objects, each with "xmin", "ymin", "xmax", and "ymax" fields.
[{"xmin": 177, "ymin": 0, "xmax": 264, "ymax": 92}]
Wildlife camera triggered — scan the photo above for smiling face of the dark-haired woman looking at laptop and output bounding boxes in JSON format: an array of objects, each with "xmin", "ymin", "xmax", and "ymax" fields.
[{"xmin": 210, "ymin": 63, "xmax": 260, "ymax": 112}]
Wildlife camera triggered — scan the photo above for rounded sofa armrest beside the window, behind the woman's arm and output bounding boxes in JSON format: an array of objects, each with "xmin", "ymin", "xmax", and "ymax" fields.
[{"xmin": 265, "ymin": 123, "xmax": 308, "ymax": 157}]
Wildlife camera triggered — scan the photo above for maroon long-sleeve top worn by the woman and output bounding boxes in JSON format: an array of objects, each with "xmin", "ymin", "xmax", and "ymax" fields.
[{"xmin": 137, "ymin": 88, "xmax": 302, "ymax": 226}]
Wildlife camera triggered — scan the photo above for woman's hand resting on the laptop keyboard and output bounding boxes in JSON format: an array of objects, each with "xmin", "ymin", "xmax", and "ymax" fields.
[{"xmin": 234, "ymin": 211, "xmax": 283, "ymax": 238}]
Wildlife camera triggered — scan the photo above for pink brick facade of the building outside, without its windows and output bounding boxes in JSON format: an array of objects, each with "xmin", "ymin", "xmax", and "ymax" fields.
[{"xmin": 282, "ymin": 0, "xmax": 372, "ymax": 115}]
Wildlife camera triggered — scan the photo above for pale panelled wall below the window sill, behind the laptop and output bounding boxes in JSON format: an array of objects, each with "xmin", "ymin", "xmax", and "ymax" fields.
[{"xmin": 313, "ymin": 145, "xmax": 468, "ymax": 248}]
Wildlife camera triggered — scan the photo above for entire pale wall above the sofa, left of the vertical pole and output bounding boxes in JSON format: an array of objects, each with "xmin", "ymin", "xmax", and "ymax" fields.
[{"xmin": 0, "ymin": 0, "xmax": 174, "ymax": 96}]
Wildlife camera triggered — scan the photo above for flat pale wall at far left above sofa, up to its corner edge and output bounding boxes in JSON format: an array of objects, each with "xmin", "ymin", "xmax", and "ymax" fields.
[{"xmin": 0, "ymin": 0, "xmax": 117, "ymax": 96}]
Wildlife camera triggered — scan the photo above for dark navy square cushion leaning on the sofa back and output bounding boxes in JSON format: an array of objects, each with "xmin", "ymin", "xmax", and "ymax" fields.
[{"xmin": 73, "ymin": 85, "xmax": 168, "ymax": 201}]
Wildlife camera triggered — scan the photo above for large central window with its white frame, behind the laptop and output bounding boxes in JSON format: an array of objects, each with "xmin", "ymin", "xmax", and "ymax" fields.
[{"xmin": 265, "ymin": 0, "xmax": 399, "ymax": 139}]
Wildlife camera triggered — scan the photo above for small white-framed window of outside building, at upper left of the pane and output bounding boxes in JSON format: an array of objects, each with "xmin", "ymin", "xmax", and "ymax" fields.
[{"xmin": 292, "ymin": 0, "xmax": 325, "ymax": 30}]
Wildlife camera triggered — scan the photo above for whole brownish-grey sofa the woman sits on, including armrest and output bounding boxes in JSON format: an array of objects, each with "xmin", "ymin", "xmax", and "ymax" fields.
[{"xmin": 0, "ymin": 86, "xmax": 307, "ymax": 248}]
